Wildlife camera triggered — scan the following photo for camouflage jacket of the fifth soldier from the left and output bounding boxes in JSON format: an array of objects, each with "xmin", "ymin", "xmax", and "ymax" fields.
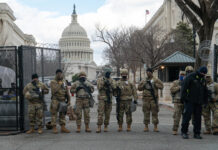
[{"xmin": 116, "ymin": 79, "xmax": 138, "ymax": 100}]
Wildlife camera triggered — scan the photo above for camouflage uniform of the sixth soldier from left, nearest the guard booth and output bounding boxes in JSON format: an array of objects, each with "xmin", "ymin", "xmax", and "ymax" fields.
[{"xmin": 138, "ymin": 77, "xmax": 163, "ymax": 125}]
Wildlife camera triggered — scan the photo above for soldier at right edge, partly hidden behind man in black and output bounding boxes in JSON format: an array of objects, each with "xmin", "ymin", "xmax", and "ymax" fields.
[{"xmin": 202, "ymin": 74, "xmax": 218, "ymax": 134}]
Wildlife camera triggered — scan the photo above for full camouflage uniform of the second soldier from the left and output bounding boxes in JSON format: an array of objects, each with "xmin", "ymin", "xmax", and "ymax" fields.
[{"xmin": 50, "ymin": 77, "xmax": 70, "ymax": 126}]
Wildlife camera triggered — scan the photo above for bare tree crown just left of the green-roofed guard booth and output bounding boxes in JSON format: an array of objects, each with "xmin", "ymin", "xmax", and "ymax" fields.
[{"xmin": 134, "ymin": 26, "xmax": 172, "ymax": 67}]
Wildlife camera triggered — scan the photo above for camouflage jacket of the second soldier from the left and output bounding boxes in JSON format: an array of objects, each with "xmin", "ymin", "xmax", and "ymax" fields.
[{"xmin": 50, "ymin": 78, "xmax": 70, "ymax": 103}]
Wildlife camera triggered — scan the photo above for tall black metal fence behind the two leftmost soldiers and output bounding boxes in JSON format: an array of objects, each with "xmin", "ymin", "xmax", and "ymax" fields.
[{"xmin": 0, "ymin": 46, "xmax": 61, "ymax": 131}]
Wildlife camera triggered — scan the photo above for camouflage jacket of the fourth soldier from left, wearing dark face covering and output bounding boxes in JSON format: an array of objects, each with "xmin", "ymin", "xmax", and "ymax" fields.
[{"xmin": 97, "ymin": 77, "xmax": 116, "ymax": 101}]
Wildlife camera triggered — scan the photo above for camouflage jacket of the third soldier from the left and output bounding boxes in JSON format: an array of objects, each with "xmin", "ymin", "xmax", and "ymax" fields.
[{"xmin": 70, "ymin": 81, "xmax": 94, "ymax": 98}]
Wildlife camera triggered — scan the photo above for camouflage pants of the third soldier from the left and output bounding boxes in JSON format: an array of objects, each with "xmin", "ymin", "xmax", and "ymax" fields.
[{"xmin": 76, "ymin": 99, "xmax": 90, "ymax": 126}]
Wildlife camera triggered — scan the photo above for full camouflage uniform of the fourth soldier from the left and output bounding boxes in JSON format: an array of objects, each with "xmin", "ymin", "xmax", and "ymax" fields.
[{"xmin": 97, "ymin": 77, "xmax": 115, "ymax": 126}]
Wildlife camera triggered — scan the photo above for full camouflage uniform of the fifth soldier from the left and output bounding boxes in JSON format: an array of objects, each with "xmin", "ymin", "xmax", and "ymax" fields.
[{"xmin": 116, "ymin": 79, "xmax": 138, "ymax": 126}]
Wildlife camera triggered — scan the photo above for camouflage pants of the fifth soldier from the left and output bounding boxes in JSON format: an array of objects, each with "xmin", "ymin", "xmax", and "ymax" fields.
[{"xmin": 118, "ymin": 100, "xmax": 132, "ymax": 125}]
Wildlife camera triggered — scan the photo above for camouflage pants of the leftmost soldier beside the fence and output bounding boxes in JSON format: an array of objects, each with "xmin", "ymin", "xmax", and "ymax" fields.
[{"xmin": 28, "ymin": 103, "xmax": 43, "ymax": 126}]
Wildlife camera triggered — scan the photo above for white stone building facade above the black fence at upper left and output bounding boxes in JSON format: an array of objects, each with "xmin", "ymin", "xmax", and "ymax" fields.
[{"xmin": 0, "ymin": 3, "xmax": 36, "ymax": 46}]
